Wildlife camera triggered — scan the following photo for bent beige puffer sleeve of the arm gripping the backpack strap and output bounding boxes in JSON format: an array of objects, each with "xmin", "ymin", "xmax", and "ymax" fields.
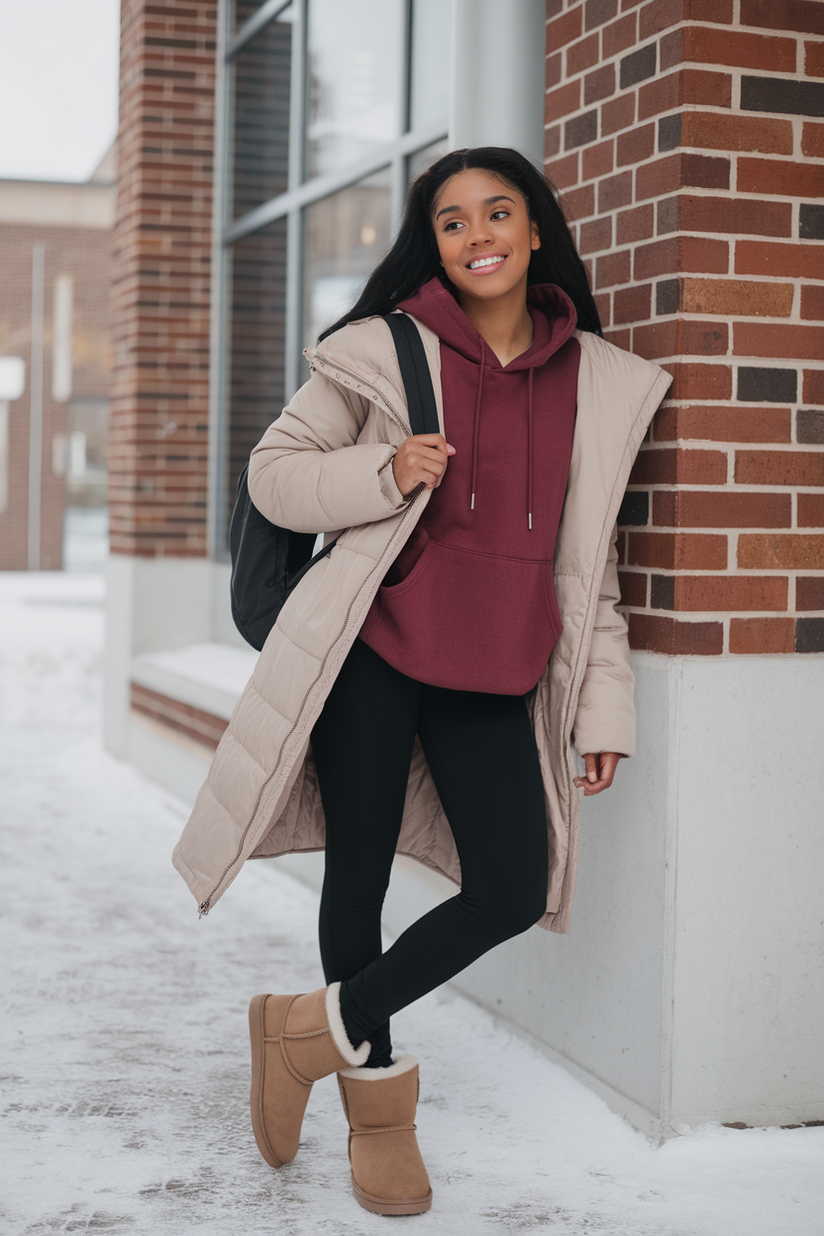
[{"xmin": 248, "ymin": 373, "xmax": 404, "ymax": 533}]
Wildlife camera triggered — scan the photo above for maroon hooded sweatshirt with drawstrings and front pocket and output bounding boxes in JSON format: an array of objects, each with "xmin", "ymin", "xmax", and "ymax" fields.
[{"xmin": 361, "ymin": 278, "xmax": 581, "ymax": 695}]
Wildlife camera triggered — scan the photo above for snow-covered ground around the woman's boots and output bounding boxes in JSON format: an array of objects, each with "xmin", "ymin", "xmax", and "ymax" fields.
[{"xmin": 0, "ymin": 574, "xmax": 824, "ymax": 1236}]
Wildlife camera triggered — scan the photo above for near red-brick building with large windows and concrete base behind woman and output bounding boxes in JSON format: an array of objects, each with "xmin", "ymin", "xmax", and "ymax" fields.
[{"xmin": 106, "ymin": 0, "xmax": 824, "ymax": 1137}]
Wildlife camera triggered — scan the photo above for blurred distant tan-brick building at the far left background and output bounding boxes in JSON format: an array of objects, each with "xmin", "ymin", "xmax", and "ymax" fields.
[{"xmin": 0, "ymin": 156, "xmax": 115, "ymax": 570}]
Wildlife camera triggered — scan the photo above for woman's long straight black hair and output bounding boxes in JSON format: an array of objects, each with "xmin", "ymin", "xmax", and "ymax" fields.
[{"xmin": 319, "ymin": 146, "xmax": 600, "ymax": 342}]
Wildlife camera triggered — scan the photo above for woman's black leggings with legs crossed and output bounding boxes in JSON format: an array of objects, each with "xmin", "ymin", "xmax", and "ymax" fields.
[{"xmin": 311, "ymin": 640, "xmax": 549, "ymax": 1067}]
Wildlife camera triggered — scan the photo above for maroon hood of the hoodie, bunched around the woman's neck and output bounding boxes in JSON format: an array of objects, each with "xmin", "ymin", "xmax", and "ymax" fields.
[{"xmin": 398, "ymin": 277, "xmax": 577, "ymax": 363}]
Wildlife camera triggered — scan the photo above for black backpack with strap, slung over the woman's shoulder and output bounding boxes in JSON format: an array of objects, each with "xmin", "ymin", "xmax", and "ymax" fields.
[{"xmin": 229, "ymin": 314, "xmax": 440, "ymax": 651}]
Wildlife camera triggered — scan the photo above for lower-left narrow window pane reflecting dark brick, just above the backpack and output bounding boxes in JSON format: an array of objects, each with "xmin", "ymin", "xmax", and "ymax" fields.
[{"xmin": 224, "ymin": 219, "xmax": 287, "ymax": 530}]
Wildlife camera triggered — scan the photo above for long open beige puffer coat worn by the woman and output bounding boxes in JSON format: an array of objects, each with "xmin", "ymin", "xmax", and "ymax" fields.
[{"xmin": 173, "ymin": 318, "xmax": 671, "ymax": 932}]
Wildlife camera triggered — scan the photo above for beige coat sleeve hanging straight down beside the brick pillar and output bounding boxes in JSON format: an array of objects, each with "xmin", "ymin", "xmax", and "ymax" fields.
[{"xmin": 574, "ymin": 528, "xmax": 635, "ymax": 755}]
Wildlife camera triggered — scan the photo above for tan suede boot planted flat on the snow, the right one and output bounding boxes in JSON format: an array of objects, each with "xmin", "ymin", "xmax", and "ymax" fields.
[{"xmin": 337, "ymin": 1056, "xmax": 432, "ymax": 1215}]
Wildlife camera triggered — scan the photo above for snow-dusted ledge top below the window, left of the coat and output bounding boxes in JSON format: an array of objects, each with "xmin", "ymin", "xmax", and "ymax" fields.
[{"xmin": 130, "ymin": 644, "xmax": 258, "ymax": 721}]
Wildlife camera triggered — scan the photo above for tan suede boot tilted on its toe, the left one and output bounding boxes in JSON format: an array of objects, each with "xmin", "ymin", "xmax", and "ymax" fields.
[{"xmin": 248, "ymin": 983, "xmax": 372, "ymax": 1167}]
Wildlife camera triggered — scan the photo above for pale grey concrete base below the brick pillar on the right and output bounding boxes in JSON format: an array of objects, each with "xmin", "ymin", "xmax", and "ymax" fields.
[{"xmin": 280, "ymin": 654, "xmax": 824, "ymax": 1141}]
